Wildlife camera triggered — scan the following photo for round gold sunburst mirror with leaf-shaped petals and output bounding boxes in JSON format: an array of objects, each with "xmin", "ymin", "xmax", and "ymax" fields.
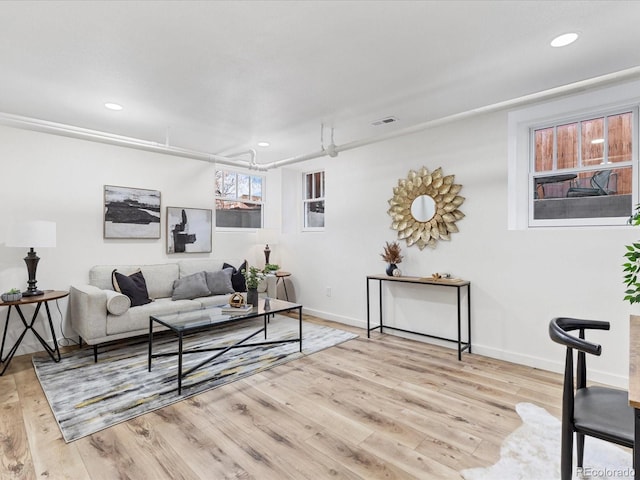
[{"xmin": 387, "ymin": 167, "xmax": 464, "ymax": 250}]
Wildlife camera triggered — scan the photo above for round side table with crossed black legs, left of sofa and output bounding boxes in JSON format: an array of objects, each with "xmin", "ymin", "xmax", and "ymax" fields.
[{"xmin": 0, "ymin": 290, "xmax": 69, "ymax": 375}]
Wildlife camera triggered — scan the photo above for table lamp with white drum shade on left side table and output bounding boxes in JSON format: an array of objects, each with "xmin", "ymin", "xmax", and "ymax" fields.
[{"xmin": 5, "ymin": 220, "xmax": 56, "ymax": 297}]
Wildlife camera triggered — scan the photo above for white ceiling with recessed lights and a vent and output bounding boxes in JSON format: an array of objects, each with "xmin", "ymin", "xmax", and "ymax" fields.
[{"xmin": 0, "ymin": 0, "xmax": 640, "ymax": 163}]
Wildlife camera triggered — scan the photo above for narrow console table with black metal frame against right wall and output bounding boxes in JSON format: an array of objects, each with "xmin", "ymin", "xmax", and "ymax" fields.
[{"xmin": 367, "ymin": 275, "xmax": 471, "ymax": 360}]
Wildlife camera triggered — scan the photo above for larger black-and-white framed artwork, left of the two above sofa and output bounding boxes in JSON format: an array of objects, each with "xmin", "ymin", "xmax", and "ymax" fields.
[{"xmin": 104, "ymin": 185, "xmax": 160, "ymax": 238}]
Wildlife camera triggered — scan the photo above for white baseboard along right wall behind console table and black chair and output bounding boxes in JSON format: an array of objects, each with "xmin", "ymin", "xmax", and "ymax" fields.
[{"xmin": 303, "ymin": 308, "xmax": 629, "ymax": 389}]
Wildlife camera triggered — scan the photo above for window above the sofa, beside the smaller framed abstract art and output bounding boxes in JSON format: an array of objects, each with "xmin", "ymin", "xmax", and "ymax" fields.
[{"xmin": 215, "ymin": 170, "xmax": 264, "ymax": 228}]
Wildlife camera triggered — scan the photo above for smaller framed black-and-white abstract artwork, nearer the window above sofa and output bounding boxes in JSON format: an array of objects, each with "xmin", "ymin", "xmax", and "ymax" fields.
[{"xmin": 167, "ymin": 207, "xmax": 212, "ymax": 253}]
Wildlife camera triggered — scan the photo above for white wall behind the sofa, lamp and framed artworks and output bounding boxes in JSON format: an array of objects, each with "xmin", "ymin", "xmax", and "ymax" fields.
[{"xmin": 0, "ymin": 127, "xmax": 272, "ymax": 354}]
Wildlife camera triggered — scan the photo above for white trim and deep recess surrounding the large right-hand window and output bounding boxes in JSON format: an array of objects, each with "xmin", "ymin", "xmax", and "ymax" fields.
[{"xmin": 507, "ymin": 81, "xmax": 640, "ymax": 230}]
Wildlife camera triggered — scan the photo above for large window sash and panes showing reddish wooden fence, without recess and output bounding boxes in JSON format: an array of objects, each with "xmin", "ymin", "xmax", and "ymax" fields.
[{"xmin": 529, "ymin": 108, "xmax": 637, "ymax": 225}]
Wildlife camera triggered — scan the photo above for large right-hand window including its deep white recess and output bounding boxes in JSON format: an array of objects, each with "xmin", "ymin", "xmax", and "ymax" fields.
[{"xmin": 507, "ymin": 80, "xmax": 640, "ymax": 230}]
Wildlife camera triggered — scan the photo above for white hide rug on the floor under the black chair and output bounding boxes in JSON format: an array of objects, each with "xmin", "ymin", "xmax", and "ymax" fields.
[{"xmin": 460, "ymin": 403, "xmax": 633, "ymax": 480}]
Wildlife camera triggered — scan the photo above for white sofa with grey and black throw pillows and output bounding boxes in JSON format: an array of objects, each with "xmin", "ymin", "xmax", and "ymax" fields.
[{"xmin": 69, "ymin": 259, "xmax": 277, "ymax": 360}]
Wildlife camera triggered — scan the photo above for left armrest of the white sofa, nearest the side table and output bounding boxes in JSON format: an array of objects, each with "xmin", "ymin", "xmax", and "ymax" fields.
[{"xmin": 69, "ymin": 285, "xmax": 107, "ymax": 344}]
